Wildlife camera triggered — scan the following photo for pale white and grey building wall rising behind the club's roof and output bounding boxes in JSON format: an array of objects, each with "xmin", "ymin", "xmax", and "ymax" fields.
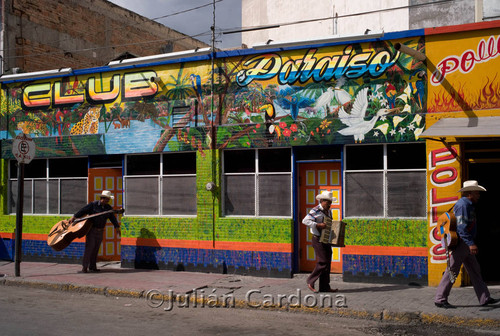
[{"xmin": 242, "ymin": 0, "xmax": 500, "ymax": 46}]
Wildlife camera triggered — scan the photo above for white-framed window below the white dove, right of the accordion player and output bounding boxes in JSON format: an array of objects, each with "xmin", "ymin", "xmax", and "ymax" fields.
[{"xmin": 344, "ymin": 143, "xmax": 427, "ymax": 218}]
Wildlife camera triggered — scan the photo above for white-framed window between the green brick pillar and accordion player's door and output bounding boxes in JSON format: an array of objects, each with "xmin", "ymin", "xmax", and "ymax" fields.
[{"xmin": 223, "ymin": 149, "xmax": 292, "ymax": 217}]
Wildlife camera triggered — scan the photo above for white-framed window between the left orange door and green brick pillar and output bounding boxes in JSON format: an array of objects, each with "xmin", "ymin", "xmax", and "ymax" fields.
[{"xmin": 124, "ymin": 152, "xmax": 196, "ymax": 216}]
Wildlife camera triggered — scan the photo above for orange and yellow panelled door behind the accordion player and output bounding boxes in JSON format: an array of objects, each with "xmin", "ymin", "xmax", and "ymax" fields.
[{"xmin": 298, "ymin": 162, "xmax": 342, "ymax": 273}]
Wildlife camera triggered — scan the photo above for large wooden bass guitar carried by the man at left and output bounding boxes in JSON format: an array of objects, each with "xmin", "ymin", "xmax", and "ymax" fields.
[{"xmin": 47, "ymin": 209, "xmax": 125, "ymax": 251}]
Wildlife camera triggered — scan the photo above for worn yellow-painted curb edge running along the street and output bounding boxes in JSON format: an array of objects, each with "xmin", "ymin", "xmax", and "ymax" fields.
[{"xmin": 0, "ymin": 277, "xmax": 500, "ymax": 329}]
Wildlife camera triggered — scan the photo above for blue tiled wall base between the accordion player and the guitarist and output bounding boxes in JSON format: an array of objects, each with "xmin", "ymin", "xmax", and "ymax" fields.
[{"xmin": 342, "ymin": 254, "xmax": 428, "ymax": 286}]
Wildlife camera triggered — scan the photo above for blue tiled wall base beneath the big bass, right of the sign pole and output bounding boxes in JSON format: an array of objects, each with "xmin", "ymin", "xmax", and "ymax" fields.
[{"xmin": 22, "ymin": 240, "xmax": 85, "ymax": 263}]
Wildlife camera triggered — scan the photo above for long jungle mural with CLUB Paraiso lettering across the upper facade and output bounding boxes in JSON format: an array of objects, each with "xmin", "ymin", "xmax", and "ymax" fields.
[{"xmin": 0, "ymin": 37, "xmax": 427, "ymax": 157}]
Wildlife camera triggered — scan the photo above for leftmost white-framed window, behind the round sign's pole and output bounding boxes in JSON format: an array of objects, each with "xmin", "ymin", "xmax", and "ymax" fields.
[{"xmin": 9, "ymin": 158, "xmax": 88, "ymax": 215}]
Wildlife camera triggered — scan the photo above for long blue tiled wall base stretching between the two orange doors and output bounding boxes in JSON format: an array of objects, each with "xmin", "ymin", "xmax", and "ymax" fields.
[{"xmin": 121, "ymin": 245, "xmax": 292, "ymax": 277}]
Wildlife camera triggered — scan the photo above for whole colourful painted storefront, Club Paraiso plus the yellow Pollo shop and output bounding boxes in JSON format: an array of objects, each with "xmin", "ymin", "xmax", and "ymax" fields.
[{"xmin": 0, "ymin": 21, "xmax": 500, "ymax": 285}]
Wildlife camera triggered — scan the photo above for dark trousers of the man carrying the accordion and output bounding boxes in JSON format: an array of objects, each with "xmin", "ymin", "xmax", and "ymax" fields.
[{"xmin": 307, "ymin": 236, "xmax": 332, "ymax": 292}]
